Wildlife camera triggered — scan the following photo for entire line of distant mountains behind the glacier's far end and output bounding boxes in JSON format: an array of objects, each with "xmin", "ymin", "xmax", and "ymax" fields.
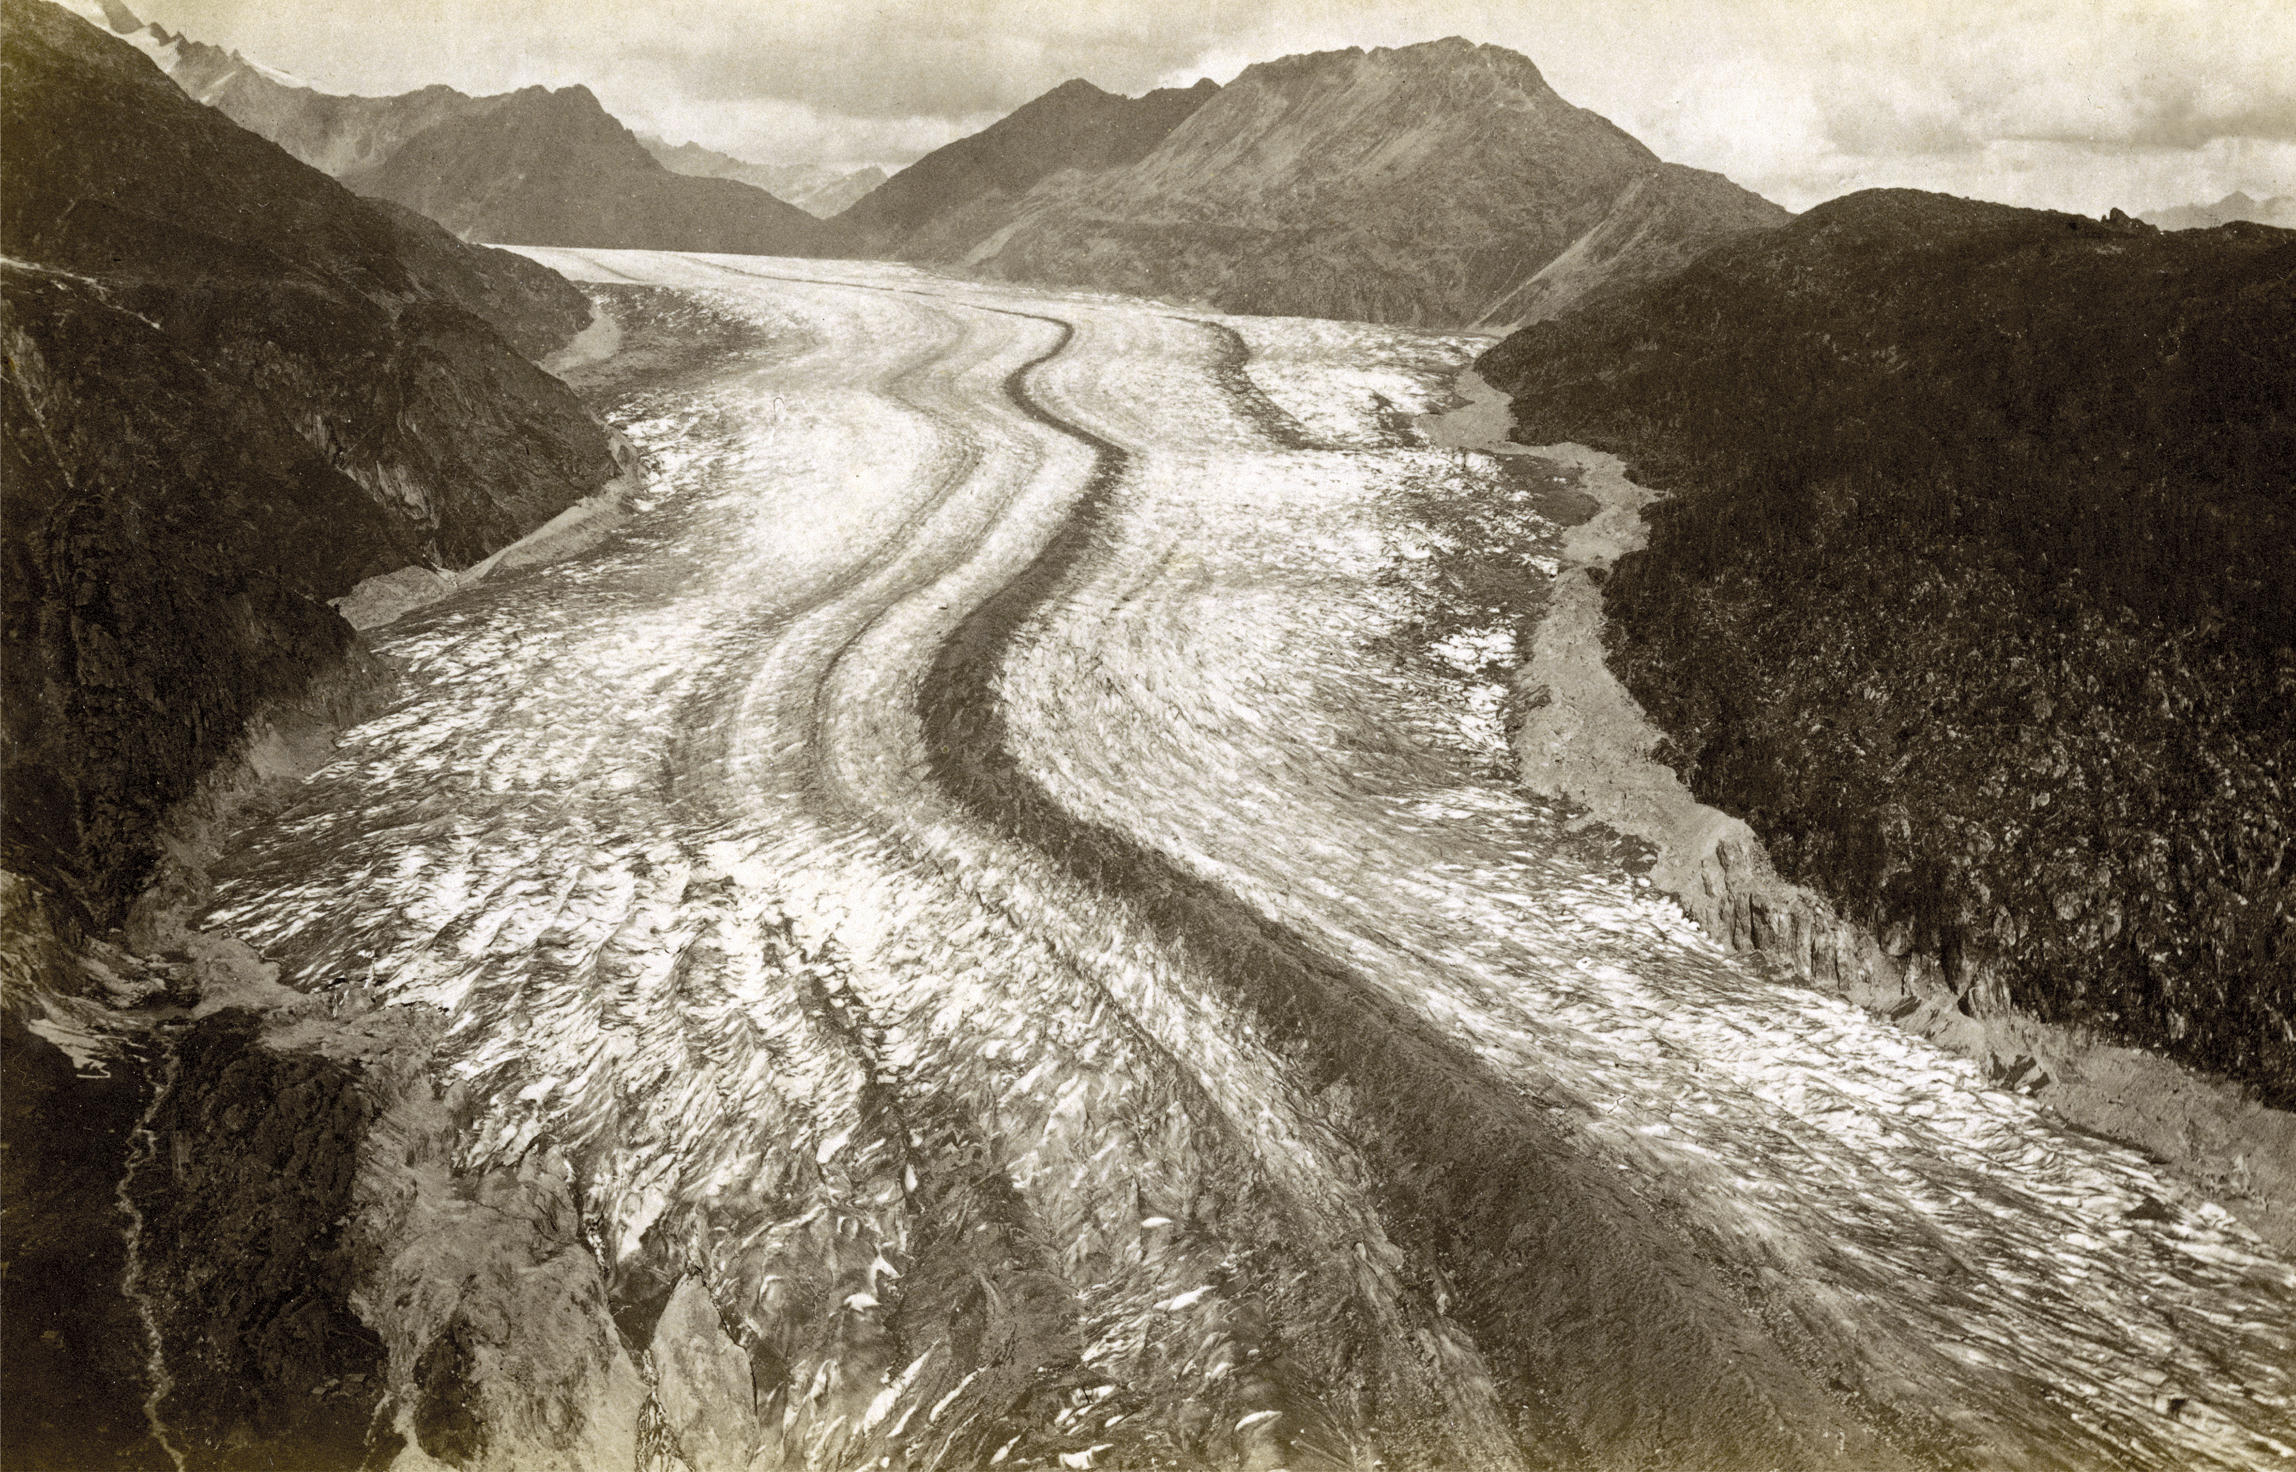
[{"xmin": 49, "ymin": 0, "xmax": 1789, "ymax": 328}]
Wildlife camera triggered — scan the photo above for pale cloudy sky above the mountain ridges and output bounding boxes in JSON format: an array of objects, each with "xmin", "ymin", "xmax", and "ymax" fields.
[{"xmin": 129, "ymin": 0, "xmax": 2296, "ymax": 214}]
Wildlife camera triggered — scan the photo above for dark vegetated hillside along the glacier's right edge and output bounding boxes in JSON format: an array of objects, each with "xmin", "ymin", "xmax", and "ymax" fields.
[{"xmin": 1481, "ymin": 191, "xmax": 2296, "ymax": 1107}]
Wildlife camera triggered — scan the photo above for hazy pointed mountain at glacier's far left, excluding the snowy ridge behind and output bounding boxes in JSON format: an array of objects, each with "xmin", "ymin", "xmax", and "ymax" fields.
[{"xmin": 342, "ymin": 87, "xmax": 833, "ymax": 255}]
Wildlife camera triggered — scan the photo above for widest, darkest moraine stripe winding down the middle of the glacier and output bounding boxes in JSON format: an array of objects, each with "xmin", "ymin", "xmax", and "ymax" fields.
[{"xmin": 918, "ymin": 312, "xmax": 1906, "ymax": 1472}]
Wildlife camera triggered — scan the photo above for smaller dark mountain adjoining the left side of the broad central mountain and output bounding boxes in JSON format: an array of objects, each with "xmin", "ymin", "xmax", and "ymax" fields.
[{"xmin": 838, "ymin": 78, "xmax": 1219, "ymax": 259}]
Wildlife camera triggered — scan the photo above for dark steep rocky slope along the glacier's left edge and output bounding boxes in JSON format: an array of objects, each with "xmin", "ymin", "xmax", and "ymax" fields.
[{"xmin": 0, "ymin": 0, "xmax": 620, "ymax": 921}]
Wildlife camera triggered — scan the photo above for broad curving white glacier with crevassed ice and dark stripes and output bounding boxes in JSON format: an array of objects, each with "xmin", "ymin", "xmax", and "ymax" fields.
[{"xmin": 209, "ymin": 250, "xmax": 2296, "ymax": 1470}]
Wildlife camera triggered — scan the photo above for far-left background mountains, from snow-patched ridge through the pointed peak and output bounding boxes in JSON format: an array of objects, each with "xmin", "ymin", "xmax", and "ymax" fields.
[{"xmin": 55, "ymin": 0, "xmax": 833, "ymax": 255}]
